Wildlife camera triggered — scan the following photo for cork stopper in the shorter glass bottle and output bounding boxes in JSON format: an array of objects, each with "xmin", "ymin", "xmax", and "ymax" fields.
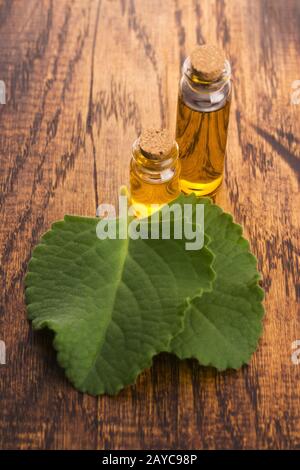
[{"xmin": 139, "ymin": 128, "xmax": 174, "ymax": 158}]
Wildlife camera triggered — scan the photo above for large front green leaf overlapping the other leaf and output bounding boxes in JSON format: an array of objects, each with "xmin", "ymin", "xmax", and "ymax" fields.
[{"xmin": 26, "ymin": 216, "xmax": 214, "ymax": 395}]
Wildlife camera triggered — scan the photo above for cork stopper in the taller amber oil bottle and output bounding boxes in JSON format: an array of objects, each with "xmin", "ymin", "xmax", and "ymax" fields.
[{"xmin": 190, "ymin": 44, "xmax": 225, "ymax": 81}]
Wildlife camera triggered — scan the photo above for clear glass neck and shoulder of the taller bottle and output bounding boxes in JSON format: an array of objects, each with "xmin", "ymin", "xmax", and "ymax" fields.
[{"xmin": 180, "ymin": 57, "xmax": 231, "ymax": 112}]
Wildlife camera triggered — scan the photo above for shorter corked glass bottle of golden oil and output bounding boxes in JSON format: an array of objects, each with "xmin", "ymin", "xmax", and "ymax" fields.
[{"xmin": 130, "ymin": 129, "xmax": 180, "ymax": 216}]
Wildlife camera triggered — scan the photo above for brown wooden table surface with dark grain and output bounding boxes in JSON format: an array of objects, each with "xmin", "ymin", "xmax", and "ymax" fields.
[{"xmin": 0, "ymin": 0, "xmax": 300, "ymax": 449}]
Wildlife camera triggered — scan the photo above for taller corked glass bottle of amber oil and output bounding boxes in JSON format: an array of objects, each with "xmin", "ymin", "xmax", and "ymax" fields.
[{"xmin": 176, "ymin": 45, "xmax": 232, "ymax": 196}]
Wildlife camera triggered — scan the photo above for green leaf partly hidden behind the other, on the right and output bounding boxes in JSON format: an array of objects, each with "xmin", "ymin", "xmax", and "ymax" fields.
[{"xmin": 170, "ymin": 195, "xmax": 264, "ymax": 370}]
